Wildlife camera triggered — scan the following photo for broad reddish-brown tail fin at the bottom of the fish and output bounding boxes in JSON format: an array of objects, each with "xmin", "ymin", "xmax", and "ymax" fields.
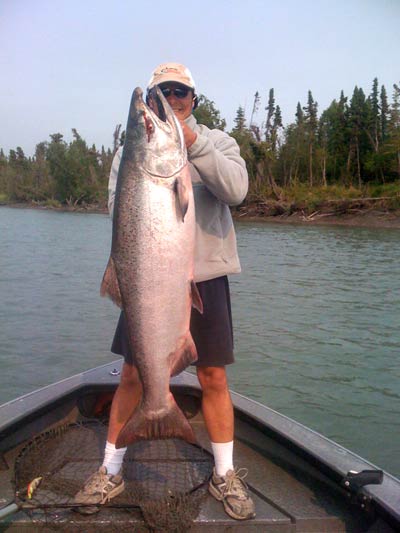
[{"xmin": 115, "ymin": 394, "xmax": 196, "ymax": 448}]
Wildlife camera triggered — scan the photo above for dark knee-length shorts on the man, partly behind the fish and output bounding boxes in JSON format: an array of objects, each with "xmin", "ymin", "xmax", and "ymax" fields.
[{"xmin": 111, "ymin": 276, "xmax": 234, "ymax": 366}]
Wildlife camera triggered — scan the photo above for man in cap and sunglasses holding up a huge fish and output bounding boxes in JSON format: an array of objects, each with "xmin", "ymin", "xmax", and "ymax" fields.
[{"xmin": 76, "ymin": 63, "xmax": 255, "ymax": 520}]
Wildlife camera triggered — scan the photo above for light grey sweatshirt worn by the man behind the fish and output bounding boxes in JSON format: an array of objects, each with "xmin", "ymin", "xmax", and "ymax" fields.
[{"xmin": 108, "ymin": 115, "xmax": 248, "ymax": 281}]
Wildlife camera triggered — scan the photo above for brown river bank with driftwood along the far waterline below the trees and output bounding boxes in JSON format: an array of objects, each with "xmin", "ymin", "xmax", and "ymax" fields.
[{"xmin": 0, "ymin": 201, "xmax": 400, "ymax": 229}]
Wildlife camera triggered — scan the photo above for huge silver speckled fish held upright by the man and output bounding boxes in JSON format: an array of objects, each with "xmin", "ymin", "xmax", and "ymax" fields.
[{"xmin": 101, "ymin": 88, "xmax": 202, "ymax": 447}]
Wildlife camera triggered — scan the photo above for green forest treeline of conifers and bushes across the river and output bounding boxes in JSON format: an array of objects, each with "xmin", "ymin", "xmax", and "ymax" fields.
[{"xmin": 0, "ymin": 78, "xmax": 400, "ymax": 211}]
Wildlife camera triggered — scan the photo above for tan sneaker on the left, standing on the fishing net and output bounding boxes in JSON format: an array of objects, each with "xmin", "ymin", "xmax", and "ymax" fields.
[{"xmin": 74, "ymin": 466, "xmax": 125, "ymax": 514}]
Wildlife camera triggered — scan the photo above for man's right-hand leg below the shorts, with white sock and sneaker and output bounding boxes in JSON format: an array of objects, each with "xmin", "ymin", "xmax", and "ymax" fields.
[{"xmin": 197, "ymin": 366, "xmax": 256, "ymax": 520}]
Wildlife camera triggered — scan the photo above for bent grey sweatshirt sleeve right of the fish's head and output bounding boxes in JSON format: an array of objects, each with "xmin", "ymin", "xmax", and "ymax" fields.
[{"xmin": 188, "ymin": 130, "xmax": 248, "ymax": 205}]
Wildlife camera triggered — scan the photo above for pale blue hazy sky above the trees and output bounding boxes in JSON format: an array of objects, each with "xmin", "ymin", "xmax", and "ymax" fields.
[{"xmin": 0, "ymin": 0, "xmax": 400, "ymax": 155}]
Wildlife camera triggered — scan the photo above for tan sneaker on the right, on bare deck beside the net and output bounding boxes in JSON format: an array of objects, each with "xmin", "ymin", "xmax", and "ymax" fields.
[{"xmin": 208, "ymin": 468, "xmax": 256, "ymax": 520}]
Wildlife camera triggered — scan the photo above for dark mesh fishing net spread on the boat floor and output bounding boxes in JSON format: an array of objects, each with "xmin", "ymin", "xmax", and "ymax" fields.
[{"xmin": 15, "ymin": 421, "xmax": 213, "ymax": 533}]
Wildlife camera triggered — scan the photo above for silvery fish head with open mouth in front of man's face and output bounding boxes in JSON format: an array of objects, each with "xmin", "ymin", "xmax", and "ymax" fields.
[{"xmin": 124, "ymin": 87, "xmax": 187, "ymax": 178}]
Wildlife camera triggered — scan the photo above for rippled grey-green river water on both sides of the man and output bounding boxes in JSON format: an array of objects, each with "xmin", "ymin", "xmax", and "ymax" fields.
[{"xmin": 0, "ymin": 207, "xmax": 400, "ymax": 477}]
